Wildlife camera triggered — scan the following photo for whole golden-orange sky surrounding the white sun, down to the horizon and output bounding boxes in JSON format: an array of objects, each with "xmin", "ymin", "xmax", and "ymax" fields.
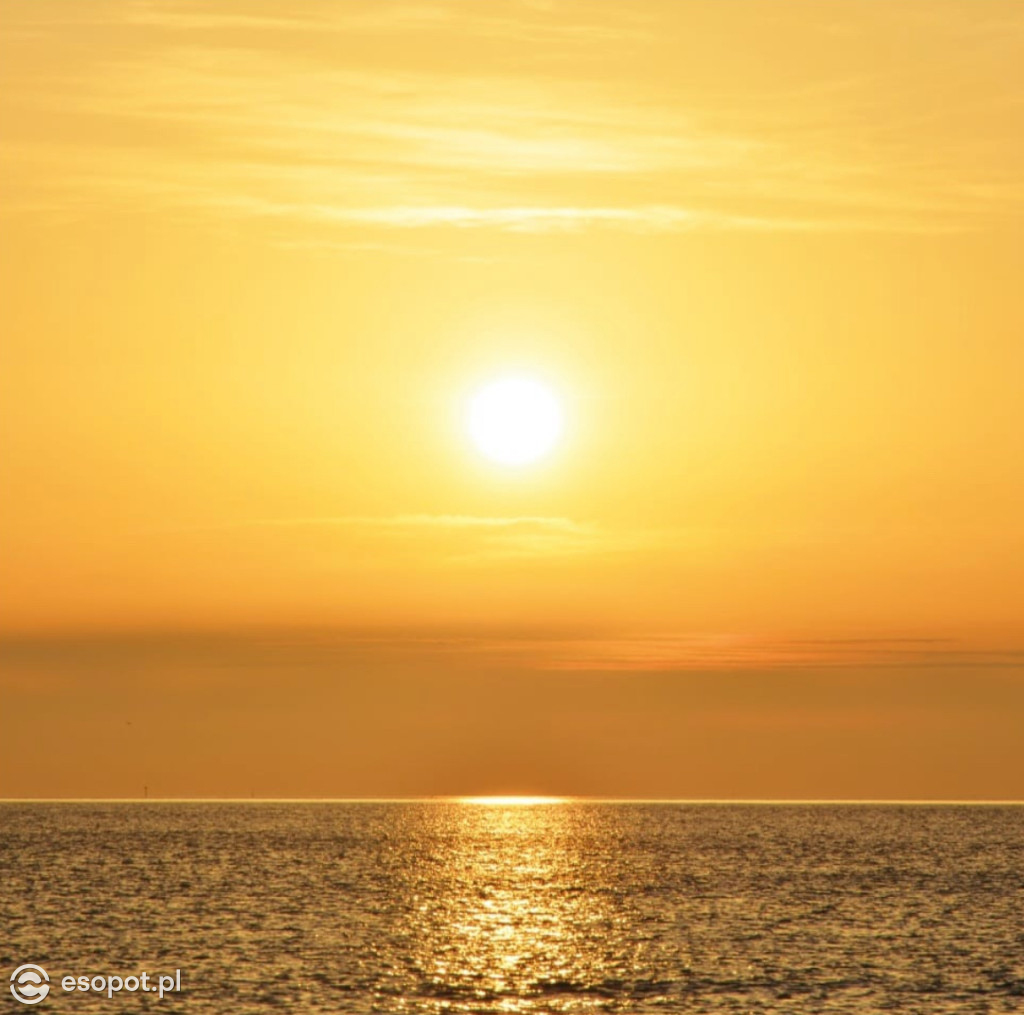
[{"xmin": 0, "ymin": 0, "xmax": 1024, "ymax": 798}]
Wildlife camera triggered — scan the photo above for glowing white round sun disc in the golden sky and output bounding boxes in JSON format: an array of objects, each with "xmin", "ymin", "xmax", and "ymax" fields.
[{"xmin": 466, "ymin": 377, "xmax": 562, "ymax": 466}]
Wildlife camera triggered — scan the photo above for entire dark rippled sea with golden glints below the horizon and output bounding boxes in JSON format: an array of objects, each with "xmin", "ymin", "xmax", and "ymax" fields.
[{"xmin": 0, "ymin": 802, "xmax": 1024, "ymax": 1015}]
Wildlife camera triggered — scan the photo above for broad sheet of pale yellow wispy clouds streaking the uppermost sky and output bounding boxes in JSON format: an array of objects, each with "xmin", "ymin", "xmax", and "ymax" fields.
[{"xmin": 4, "ymin": 3, "xmax": 1024, "ymax": 241}]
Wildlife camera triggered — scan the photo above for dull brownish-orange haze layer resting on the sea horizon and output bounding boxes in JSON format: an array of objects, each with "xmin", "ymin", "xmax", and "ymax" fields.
[{"xmin": 0, "ymin": 629, "xmax": 1024, "ymax": 799}]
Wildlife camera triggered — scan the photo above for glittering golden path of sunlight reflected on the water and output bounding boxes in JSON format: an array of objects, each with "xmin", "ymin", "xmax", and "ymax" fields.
[{"xmin": 401, "ymin": 797, "xmax": 628, "ymax": 1012}]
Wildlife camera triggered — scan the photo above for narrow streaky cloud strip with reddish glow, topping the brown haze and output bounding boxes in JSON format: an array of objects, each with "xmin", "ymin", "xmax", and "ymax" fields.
[{"xmin": 0, "ymin": 622, "xmax": 1024, "ymax": 683}]
